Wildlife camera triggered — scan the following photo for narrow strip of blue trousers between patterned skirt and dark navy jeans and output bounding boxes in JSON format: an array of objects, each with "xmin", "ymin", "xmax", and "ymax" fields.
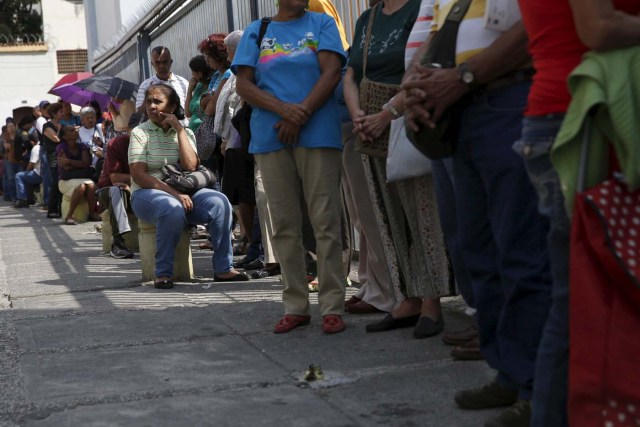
[{"xmin": 431, "ymin": 159, "xmax": 476, "ymax": 308}]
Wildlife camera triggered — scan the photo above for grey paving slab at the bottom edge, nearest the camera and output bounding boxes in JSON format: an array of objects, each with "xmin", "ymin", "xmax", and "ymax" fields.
[{"xmin": 24, "ymin": 385, "xmax": 361, "ymax": 427}]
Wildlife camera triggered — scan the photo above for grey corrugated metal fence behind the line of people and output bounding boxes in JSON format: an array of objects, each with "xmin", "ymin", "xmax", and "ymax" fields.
[{"xmin": 92, "ymin": 0, "xmax": 368, "ymax": 82}]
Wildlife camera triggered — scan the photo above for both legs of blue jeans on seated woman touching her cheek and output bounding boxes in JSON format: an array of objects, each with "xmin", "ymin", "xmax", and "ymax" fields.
[{"xmin": 131, "ymin": 188, "xmax": 233, "ymax": 277}]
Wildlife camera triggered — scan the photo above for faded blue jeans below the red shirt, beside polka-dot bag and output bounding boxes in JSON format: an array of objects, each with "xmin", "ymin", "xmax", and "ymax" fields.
[{"xmin": 513, "ymin": 115, "xmax": 570, "ymax": 427}]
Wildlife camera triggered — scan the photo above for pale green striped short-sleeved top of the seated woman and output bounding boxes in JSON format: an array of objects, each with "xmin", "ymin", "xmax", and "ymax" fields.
[{"xmin": 129, "ymin": 120, "xmax": 198, "ymax": 192}]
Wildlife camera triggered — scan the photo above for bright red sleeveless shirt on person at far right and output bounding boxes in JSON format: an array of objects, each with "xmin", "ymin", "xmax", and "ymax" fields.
[{"xmin": 519, "ymin": 0, "xmax": 640, "ymax": 116}]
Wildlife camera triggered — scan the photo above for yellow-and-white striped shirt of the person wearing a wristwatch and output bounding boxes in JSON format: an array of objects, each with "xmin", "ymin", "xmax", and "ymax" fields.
[{"xmin": 431, "ymin": 0, "xmax": 502, "ymax": 64}]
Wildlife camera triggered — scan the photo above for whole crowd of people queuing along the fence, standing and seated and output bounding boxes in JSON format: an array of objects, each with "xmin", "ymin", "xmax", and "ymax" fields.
[{"xmin": 3, "ymin": 0, "xmax": 640, "ymax": 427}]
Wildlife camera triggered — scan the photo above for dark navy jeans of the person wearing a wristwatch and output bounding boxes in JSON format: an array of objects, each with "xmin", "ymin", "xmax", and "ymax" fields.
[{"xmin": 453, "ymin": 83, "xmax": 551, "ymax": 400}]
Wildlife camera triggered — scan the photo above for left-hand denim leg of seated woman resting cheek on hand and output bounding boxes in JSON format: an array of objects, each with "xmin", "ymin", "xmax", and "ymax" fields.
[{"xmin": 131, "ymin": 189, "xmax": 187, "ymax": 280}]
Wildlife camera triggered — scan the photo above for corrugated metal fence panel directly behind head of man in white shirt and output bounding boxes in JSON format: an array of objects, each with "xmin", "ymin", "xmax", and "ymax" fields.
[{"xmin": 151, "ymin": 0, "xmax": 229, "ymax": 79}]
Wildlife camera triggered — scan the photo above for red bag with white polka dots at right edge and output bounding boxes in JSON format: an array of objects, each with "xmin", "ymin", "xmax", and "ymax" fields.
[{"xmin": 569, "ymin": 179, "xmax": 640, "ymax": 427}]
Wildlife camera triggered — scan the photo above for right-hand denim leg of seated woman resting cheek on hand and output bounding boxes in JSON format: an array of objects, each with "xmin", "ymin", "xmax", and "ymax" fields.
[{"xmin": 187, "ymin": 188, "xmax": 233, "ymax": 276}]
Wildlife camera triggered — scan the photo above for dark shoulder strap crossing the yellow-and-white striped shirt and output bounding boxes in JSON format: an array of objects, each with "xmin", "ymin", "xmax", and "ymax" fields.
[{"xmin": 421, "ymin": 0, "xmax": 472, "ymax": 68}]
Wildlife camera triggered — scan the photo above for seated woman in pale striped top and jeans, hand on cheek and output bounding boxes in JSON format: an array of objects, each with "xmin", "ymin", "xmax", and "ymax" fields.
[{"xmin": 129, "ymin": 84, "xmax": 248, "ymax": 289}]
